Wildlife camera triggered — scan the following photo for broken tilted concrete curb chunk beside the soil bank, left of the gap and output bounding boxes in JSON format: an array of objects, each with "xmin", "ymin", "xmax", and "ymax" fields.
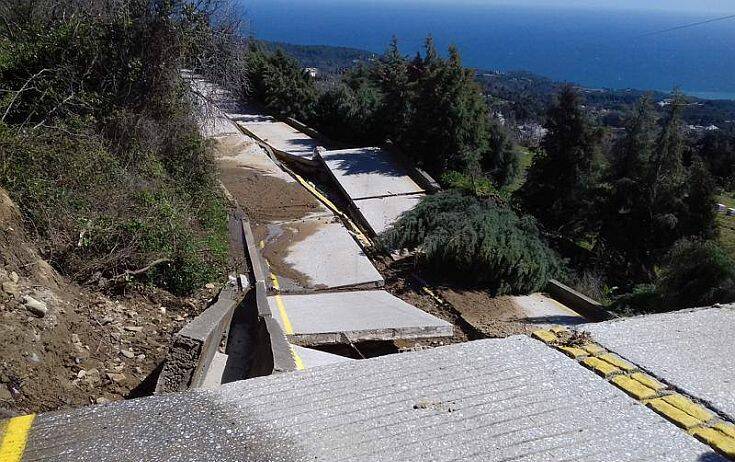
[{"xmin": 156, "ymin": 285, "xmax": 242, "ymax": 394}]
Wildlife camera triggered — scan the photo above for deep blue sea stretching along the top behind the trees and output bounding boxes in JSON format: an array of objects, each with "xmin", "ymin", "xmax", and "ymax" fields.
[{"xmin": 245, "ymin": 0, "xmax": 735, "ymax": 99}]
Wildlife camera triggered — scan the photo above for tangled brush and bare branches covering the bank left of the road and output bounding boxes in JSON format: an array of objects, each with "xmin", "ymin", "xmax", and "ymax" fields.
[{"xmin": 0, "ymin": 0, "xmax": 233, "ymax": 293}]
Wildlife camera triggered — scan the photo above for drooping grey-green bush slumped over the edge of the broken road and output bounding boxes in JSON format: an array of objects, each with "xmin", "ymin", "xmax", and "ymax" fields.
[{"xmin": 382, "ymin": 191, "xmax": 560, "ymax": 294}]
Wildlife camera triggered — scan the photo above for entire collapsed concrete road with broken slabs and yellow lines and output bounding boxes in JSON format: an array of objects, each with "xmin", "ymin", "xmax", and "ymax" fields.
[{"xmin": 0, "ymin": 76, "xmax": 735, "ymax": 462}]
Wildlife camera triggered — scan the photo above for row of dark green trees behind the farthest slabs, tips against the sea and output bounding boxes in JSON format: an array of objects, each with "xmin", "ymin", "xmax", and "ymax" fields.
[{"xmin": 250, "ymin": 37, "xmax": 520, "ymax": 187}]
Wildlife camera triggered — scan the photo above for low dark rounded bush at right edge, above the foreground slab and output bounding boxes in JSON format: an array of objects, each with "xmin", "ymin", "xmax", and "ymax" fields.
[{"xmin": 656, "ymin": 239, "xmax": 735, "ymax": 310}]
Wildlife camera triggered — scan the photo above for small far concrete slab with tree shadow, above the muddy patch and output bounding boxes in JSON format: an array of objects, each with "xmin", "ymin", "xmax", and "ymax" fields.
[{"xmin": 238, "ymin": 120, "xmax": 318, "ymax": 161}]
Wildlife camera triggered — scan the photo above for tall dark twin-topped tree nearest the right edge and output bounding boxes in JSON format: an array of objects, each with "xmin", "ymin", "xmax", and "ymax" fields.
[{"xmin": 598, "ymin": 96, "xmax": 716, "ymax": 284}]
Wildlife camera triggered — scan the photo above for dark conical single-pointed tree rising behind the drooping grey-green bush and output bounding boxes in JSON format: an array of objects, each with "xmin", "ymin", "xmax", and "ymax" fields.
[{"xmin": 519, "ymin": 86, "xmax": 601, "ymax": 239}]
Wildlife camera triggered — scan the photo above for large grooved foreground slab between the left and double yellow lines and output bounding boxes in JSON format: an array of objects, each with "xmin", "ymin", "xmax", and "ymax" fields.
[{"xmin": 24, "ymin": 337, "xmax": 724, "ymax": 462}]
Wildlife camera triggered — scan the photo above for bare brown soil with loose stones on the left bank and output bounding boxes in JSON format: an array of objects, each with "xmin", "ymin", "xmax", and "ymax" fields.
[{"xmin": 0, "ymin": 189, "xmax": 214, "ymax": 418}]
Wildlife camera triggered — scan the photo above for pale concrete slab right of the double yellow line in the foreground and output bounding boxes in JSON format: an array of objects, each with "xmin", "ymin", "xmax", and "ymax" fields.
[{"xmin": 580, "ymin": 305, "xmax": 735, "ymax": 420}]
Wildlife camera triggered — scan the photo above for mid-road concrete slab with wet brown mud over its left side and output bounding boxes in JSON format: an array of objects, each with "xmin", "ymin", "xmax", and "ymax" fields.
[{"xmin": 256, "ymin": 218, "xmax": 385, "ymax": 293}]
